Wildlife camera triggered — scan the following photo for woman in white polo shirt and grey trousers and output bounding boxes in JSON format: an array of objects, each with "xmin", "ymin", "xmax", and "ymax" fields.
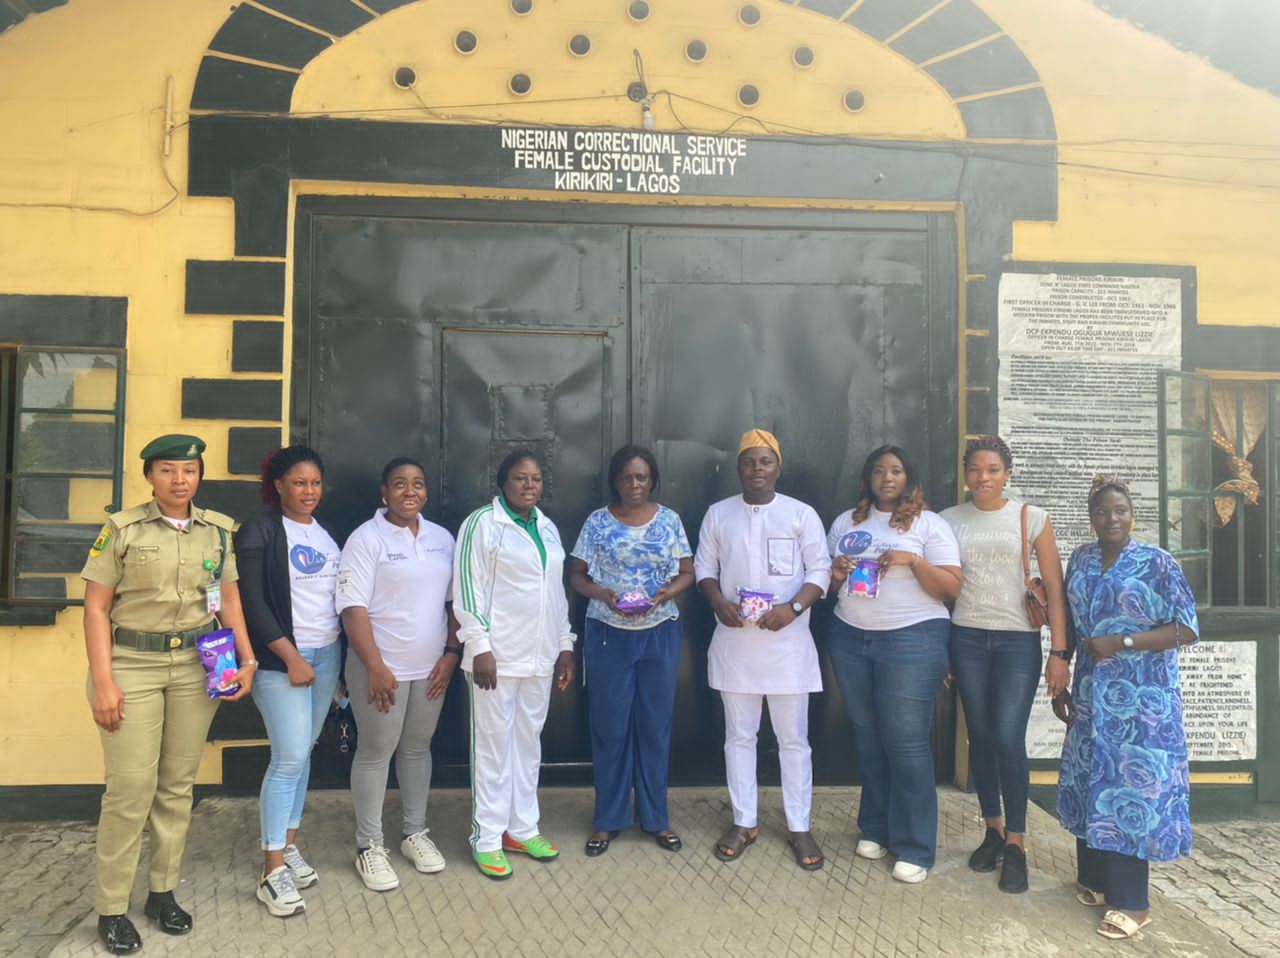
[{"xmin": 337, "ymin": 457, "xmax": 462, "ymax": 891}]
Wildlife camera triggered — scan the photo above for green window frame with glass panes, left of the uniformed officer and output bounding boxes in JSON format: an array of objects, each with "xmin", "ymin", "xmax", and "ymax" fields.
[{"xmin": 0, "ymin": 345, "xmax": 125, "ymax": 608}]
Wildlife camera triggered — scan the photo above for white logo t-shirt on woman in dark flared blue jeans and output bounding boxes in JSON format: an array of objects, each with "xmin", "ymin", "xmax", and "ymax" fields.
[{"xmin": 827, "ymin": 508, "xmax": 960, "ymax": 630}]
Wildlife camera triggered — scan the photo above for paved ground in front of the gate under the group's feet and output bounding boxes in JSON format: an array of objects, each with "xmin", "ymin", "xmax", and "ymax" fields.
[{"xmin": 0, "ymin": 789, "xmax": 1280, "ymax": 958}]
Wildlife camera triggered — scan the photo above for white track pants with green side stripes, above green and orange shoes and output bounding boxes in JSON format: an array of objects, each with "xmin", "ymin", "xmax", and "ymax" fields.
[{"xmin": 467, "ymin": 672, "xmax": 552, "ymax": 852}]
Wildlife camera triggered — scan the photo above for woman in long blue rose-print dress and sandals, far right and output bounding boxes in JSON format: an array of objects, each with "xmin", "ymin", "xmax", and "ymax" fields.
[{"xmin": 1053, "ymin": 476, "xmax": 1199, "ymax": 939}]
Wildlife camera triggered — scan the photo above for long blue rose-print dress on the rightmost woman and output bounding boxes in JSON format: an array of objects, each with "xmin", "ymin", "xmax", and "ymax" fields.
[{"xmin": 1057, "ymin": 540, "xmax": 1199, "ymax": 862}]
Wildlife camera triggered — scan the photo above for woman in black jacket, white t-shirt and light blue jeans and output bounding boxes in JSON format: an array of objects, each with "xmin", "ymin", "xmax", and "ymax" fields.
[{"xmin": 236, "ymin": 446, "xmax": 342, "ymax": 918}]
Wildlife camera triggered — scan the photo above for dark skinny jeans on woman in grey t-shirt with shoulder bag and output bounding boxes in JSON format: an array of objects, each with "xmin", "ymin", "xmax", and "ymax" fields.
[{"xmin": 951, "ymin": 625, "xmax": 1042, "ymax": 834}]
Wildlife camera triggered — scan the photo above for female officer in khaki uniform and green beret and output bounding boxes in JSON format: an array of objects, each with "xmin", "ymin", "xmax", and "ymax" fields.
[{"xmin": 81, "ymin": 435, "xmax": 257, "ymax": 954}]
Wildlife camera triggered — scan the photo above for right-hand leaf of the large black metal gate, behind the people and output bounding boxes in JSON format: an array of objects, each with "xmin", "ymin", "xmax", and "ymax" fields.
[{"xmin": 631, "ymin": 222, "xmax": 956, "ymax": 781}]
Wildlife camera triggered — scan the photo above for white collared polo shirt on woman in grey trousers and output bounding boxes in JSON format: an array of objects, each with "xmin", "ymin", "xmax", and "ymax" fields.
[{"xmin": 334, "ymin": 510, "xmax": 453, "ymax": 681}]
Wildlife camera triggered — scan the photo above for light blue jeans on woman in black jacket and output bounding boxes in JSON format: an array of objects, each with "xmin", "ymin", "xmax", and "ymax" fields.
[{"xmin": 252, "ymin": 642, "xmax": 342, "ymax": 852}]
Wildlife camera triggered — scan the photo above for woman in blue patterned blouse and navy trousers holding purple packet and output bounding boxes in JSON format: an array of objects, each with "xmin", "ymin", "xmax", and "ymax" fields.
[{"xmin": 568, "ymin": 446, "xmax": 694, "ymax": 857}]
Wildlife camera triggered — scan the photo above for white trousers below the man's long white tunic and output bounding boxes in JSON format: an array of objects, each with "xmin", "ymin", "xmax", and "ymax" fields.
[{"xmin": 721, "ymin": 692, "xmax": 813, "ymax": 831}]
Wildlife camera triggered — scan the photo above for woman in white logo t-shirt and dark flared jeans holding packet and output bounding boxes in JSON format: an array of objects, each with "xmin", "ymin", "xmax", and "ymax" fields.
[{"xmin": 827, "ymin": 446, "xmax": 963, "ymax": 884}]
